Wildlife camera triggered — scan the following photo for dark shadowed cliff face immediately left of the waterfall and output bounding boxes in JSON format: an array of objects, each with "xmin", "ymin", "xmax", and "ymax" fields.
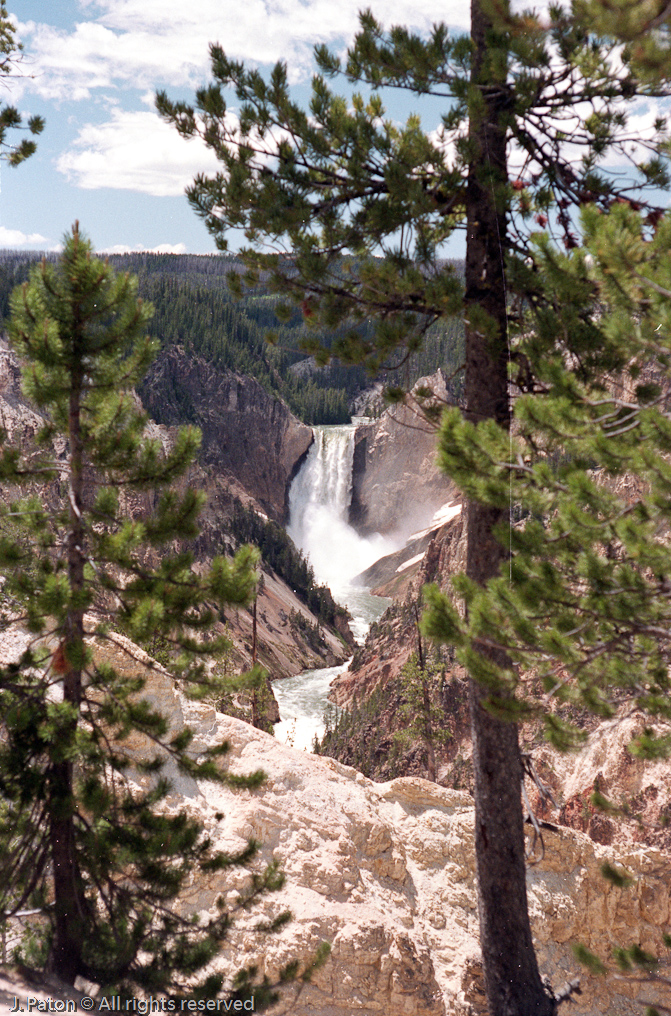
[{"xmin": 141, "ymin": 346, "xmax": 313, "ymax": 521}]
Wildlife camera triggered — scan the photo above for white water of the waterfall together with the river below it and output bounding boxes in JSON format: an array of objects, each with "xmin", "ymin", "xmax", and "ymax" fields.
[{"xmin": 272, "ymin": 424, "xmax": 399, "ymax": 751}]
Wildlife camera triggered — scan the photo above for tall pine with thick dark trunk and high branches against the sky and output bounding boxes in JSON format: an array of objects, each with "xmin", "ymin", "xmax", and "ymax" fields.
[{"xmin": 157, "ymin": 0, "xmax": 669, "ymax": 1016}]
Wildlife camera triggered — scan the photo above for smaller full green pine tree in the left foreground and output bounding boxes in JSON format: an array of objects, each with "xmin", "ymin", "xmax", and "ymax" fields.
[{"xmin": 0, "ymin": 225, "xmax": 292, "ymax": 1006}]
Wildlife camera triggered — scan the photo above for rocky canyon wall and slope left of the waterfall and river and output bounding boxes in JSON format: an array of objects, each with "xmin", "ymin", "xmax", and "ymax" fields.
[{"xmin": 0, "ymin": 341, "xmax": 350, "ymax": 678}]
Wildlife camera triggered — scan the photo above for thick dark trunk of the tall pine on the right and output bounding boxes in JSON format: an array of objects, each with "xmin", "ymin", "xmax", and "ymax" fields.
[{"xmin": 465, "ymin": 0, "xmax": 555, "ymax": 1016}]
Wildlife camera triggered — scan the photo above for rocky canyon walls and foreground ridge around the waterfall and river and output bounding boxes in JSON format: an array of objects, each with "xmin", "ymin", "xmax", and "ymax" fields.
[{"xmin": 0, "ymin": 327, "xmax": 671, "ymax": 1016}]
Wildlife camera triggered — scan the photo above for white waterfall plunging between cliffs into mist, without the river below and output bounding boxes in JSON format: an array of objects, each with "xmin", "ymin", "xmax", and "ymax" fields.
[{"xmin": 288, "ymin": 425, "xmax": 395, "ymax": 602}]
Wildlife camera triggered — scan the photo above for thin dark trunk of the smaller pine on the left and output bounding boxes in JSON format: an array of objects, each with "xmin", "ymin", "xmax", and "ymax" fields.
[{"xmin": 49, "ymin": 319, "xmax": 86, "ymax": 983}]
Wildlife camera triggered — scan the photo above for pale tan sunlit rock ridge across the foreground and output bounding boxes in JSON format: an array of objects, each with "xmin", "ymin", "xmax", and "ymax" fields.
[{"xmin": 107, "ymin": 650, "xmax": 671, "ymax": 1016}]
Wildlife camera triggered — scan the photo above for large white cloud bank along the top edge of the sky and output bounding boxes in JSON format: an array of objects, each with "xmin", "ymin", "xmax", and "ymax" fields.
[{"xmin": 19, "ymin": 0, "xmax": 469, "ymax": 100}]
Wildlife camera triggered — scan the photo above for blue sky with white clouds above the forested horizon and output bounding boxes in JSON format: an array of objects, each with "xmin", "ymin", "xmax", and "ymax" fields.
[{"xmin": 0, "ymin": 0, "xmax": 469, "ymax": 254}]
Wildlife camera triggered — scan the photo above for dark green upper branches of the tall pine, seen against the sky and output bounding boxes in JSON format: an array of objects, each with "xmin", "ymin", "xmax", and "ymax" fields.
[{"xmin": 157, "ymin": 4, "xmax": 668, "ymax": 386}]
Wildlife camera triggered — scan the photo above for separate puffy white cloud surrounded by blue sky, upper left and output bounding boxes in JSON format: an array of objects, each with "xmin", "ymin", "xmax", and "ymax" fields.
[{"xmin": 56, "ymin": 110, "xmax": 219, "ymax": 197}]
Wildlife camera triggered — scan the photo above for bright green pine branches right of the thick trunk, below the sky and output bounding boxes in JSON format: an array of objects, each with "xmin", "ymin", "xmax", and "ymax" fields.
[{"xmin": 425, "ymin": 205, "xmax": 671, "ymax": 758}]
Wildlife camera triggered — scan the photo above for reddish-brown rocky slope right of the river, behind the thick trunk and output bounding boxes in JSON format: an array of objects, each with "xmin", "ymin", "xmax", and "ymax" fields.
[{"xmin": 330, "ymin": 503, "xmax": 671, "ymax": 869}]
